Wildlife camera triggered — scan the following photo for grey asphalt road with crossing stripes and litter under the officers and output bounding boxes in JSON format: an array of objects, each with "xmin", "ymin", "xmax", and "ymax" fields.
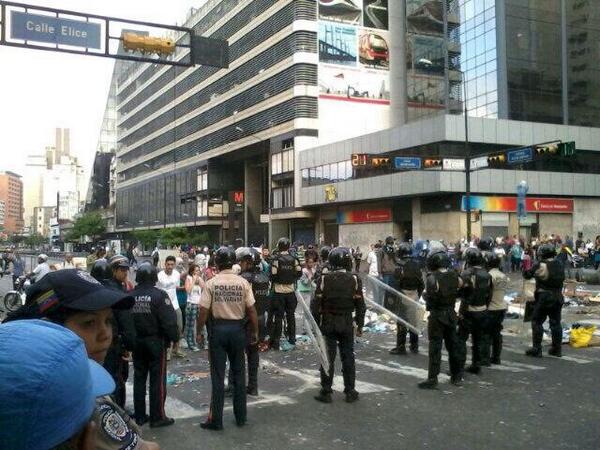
[{"xmin": 0, "ymin": 278, "xmax": 600, "ymax": 450}]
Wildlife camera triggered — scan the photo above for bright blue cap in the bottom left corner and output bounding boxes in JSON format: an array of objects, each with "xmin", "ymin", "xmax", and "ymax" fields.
[{"xmin": 0, "ymin": 320, "xmax": 115, "ymax": 450}]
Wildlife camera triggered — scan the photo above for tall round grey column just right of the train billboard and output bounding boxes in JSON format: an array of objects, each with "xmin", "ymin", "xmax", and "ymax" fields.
[{"xmin": 388, "ymin": 0, "xmax": 408, "ymax": 128}]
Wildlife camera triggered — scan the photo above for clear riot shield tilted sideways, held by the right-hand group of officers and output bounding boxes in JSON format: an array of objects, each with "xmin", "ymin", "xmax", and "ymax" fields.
[{"xmin": 361, "ymin": 274, "xmax": 425, "ymax": 334}]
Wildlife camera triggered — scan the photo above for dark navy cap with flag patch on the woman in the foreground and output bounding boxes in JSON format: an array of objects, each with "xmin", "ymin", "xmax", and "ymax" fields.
[{"xmin": 26, "ymin": 269, "xmax": 135, "ymax": 313}]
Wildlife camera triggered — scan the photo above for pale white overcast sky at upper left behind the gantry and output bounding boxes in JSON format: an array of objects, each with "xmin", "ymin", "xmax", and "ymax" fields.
[{"xmin": 0, "ymin": 0, "xmax": 205, "ymax": 175}]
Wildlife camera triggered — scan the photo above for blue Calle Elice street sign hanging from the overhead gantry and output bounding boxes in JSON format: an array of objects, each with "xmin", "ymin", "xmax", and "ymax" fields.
[{"xmin": 10, "ymin": 11, "xmax": 101, "ymax": 49}]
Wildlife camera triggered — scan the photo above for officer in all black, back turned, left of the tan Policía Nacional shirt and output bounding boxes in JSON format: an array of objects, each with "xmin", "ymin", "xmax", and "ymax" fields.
[{"xmin": 131, "ymin": 262, "xmax": 178, "ymax": 427}]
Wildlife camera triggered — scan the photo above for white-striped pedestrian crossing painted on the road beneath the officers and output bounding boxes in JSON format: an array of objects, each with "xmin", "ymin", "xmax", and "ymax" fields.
[{"xmin": 126, "ymin": 338, "xmax": 600, "ymax": 419}]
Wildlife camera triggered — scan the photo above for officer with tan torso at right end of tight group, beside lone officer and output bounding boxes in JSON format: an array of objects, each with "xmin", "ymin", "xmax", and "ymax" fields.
[{"xmin": 483, "ymin": 252, "xmax": 509, "ymax": 364}]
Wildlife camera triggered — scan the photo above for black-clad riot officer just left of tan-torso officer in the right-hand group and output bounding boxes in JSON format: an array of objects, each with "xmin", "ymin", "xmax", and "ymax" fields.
[{"xmin": 458, "ymin": 248, "xmax": 493, "ymax": 374}]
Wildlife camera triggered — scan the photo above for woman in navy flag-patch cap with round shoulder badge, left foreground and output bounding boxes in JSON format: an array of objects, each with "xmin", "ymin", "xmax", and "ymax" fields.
[{"xmin": 0, "ymin": 269, "xmax": 159, "ymax": 450}]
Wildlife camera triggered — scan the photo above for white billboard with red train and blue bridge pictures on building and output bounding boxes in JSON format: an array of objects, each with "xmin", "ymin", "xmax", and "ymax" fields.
[{"xmin": 318, "ymin": 0, "xmax": 391, "ymax": 144}]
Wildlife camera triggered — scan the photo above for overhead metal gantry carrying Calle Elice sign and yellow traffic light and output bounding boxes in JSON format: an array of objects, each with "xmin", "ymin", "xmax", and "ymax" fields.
[{"xmin": 0, "ymin": 0, "xmax": 229, "ymax": 68}]
